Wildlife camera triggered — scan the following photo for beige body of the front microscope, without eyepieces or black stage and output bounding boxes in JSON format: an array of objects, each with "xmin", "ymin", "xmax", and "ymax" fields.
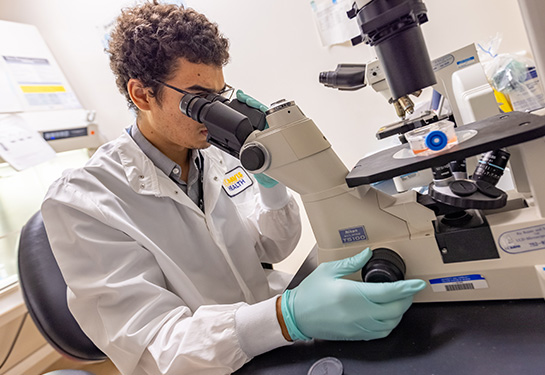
[{"xmin": 241, "ymin": 102, "xmax": 545, "ymax": 302}]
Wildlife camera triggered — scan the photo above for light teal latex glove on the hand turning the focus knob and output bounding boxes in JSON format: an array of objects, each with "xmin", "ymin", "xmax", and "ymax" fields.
[{"xmin": 281, "ymin": 249, "xmax": 426, "ymax": 340}]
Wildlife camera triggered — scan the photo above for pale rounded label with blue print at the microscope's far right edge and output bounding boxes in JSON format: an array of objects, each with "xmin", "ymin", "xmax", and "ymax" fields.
[{"xmin": 498, "ymin": 224, "xmax": 545, "ymax": 254}]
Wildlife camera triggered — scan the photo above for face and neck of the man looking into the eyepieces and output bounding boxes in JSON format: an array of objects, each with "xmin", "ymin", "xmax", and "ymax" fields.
[{"xmin": 138, "ymin": 59, "xmax": 225, "ymax": 160}]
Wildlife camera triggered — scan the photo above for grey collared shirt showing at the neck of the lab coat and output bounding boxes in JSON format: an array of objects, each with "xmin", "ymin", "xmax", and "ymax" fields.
[{"xmin": 129, "ymin": 124, "xmax": 201, "ymax": 206}]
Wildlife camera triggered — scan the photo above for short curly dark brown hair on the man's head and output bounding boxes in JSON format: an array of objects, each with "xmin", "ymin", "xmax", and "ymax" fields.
[{"xmin": 106, "ymin": 0, "xmax": 229, "ymax": 111}]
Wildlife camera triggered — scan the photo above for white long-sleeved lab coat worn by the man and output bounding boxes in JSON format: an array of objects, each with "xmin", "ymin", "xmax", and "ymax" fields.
[{"xmin": 42, "ymin": 132, "xmax": 301, "ymax": 375}]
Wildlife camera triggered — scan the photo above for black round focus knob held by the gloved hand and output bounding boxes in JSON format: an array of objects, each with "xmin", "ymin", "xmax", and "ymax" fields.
[{"xmin": 361, "ymin": 248, "xmax": 406, "ymax": 283}]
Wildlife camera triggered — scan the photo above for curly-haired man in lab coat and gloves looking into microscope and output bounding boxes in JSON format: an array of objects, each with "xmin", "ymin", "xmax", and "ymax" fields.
[{"xmin": 42, "ymin": 2, "xmax": 422, "ymax": 374}]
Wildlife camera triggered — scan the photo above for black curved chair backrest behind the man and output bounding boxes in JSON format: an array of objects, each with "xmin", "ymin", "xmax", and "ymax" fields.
[{"xmin": 18, "ymin": 212, "xmax": 106, "ymax": 361}]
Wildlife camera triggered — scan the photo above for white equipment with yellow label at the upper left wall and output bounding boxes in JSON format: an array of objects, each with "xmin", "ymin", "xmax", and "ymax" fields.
[{"xmin": 0, "ymin": 21, "xmax": 104, "ymax": 161}]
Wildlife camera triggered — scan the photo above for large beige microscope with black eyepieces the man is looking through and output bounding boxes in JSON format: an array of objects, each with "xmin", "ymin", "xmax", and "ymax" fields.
[{"xmin": 180, "ymin": 0, "xmax": 545, "ymax": 302}]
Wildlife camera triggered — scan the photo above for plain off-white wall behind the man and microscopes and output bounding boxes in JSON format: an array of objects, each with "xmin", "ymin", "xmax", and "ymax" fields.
[{"xmin": 0, "ymin": 0, "xmax": 529, "ymax": 270}]
